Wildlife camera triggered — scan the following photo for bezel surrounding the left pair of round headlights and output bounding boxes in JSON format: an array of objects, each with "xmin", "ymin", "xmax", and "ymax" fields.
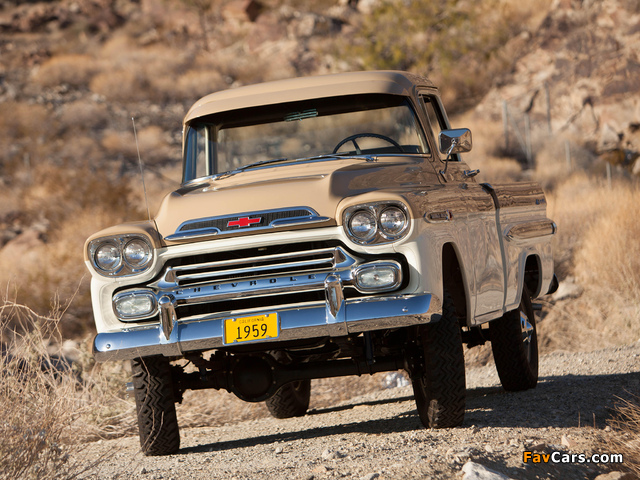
[{"xmin": 88, "ymin": 234, "xmax": 155, "ymax": 277}]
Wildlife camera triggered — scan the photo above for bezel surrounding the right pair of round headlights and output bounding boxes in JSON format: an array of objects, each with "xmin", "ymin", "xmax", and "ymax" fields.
[{"xmin": 342, "ymin": 200, "xmax": 411, "ymax": 245}]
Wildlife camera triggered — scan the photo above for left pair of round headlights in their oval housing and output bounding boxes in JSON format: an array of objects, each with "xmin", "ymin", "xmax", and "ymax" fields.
[{"xmin": 89, "ymin": 235, "xmax": 153, "ymax": 276}]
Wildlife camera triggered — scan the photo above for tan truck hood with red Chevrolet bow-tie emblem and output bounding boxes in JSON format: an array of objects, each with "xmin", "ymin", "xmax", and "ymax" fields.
[{"xmin": 156, "ymin": 157, "xmax": 438, "ymax": 242}]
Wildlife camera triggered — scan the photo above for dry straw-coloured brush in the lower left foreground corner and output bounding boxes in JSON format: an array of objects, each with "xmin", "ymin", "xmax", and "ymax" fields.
[{"xmin": 0, "ymin": 299, "xmax": 132, "ymax": 479}]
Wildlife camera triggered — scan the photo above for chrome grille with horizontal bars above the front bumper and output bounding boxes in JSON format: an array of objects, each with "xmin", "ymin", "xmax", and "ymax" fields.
[{"xmin": 125, "ymin": 242, "xmax": 402, "ymax": 322}]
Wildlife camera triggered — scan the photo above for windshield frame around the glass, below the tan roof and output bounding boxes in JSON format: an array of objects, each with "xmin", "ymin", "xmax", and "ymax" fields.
[{"xmin": 182, "ymin": 93, "xmax": 432, "ymax": 185}]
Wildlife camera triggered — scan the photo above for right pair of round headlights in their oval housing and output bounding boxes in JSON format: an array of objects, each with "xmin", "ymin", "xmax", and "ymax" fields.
[{"xmin": 344, "ymin": 202, "xmax": 410, "ymax": 245}]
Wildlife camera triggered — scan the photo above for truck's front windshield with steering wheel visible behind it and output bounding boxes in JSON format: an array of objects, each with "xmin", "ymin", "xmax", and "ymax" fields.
[{"xmin": 183, "ymin": 95, "xmax": 429, "ymax": 182}]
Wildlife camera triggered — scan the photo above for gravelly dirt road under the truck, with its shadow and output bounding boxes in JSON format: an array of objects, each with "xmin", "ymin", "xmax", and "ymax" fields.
[{"xmin": 80, "ymin": 342, "xmax": 640, "ymax": 480}]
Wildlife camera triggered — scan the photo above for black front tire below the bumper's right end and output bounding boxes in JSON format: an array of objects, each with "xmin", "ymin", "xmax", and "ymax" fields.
[{"xmin": 412, "ymin": 293, "xmax": 466, "ymax": 428}]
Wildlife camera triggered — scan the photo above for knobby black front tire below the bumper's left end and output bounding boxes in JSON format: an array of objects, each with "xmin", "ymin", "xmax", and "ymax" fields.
[{"xmin": 131, "ymin": 357, "xmax": 180, "ymax": 456}]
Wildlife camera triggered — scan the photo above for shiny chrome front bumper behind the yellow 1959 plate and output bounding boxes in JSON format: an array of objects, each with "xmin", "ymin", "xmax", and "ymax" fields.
[{"xmin": 93, "ymin": 294, "xmax": 441, "ymax": 362}]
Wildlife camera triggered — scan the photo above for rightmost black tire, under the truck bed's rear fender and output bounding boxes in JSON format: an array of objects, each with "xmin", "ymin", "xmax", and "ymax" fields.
[{"xmin": 489, "ymin": 287, "xmax": 538, "ymax": 392}]
